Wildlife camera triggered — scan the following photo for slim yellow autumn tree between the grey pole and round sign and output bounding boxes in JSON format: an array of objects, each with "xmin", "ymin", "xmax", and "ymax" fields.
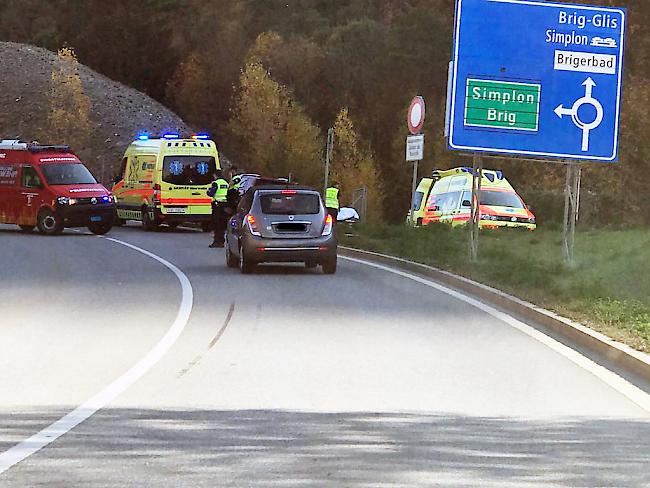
[{"xmin": 331, "ymin": 108, "xmax": 384, "ymax": 221}]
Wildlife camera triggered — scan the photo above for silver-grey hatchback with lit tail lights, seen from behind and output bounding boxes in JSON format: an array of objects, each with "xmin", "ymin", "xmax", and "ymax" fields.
[{"xmin": 225, "ymin": 185, "xmax": 338, "ymax": 274}]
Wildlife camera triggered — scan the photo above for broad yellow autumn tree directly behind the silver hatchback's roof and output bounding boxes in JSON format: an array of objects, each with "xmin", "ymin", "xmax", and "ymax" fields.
[{"xmin": 229, "ymin": 62, "xmax": 322, "ymax": 185}]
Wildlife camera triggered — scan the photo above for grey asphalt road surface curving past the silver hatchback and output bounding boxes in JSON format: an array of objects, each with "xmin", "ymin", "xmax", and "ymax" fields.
[{"xmin": 0, "ymin": 225, "xmax": 650, "ymax": 488}]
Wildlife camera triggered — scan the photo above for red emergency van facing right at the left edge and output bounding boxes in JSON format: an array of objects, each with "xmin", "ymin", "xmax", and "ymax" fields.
[{"xmin": 0, "ymin": 140, "xmax": 115, "ymax": 235}]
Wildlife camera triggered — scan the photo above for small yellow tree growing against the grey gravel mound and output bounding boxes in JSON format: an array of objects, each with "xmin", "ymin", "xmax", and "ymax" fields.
[{"xmin": 46, "ymin": 47, "xmax": 91, "ymax": 151}]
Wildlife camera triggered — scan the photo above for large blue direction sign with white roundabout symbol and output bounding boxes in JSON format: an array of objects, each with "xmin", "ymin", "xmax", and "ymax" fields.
[{"xmin": 449, "ymin": 0, "xmax": 626, "ymax": 161}]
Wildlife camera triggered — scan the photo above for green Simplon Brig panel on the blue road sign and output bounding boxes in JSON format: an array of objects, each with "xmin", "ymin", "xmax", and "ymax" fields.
[{"xmin": 465, "ymin": 78, "xmax": 542, "ymax": 132}]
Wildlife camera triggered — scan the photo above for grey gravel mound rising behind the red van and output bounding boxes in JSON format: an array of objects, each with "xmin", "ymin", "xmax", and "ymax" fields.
[{"xmin": 0, "ymin": 42, "xmax": 191, "ymax": 183}]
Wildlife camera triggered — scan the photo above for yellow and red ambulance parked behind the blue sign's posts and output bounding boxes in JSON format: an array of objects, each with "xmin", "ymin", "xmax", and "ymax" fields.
[{"xmin": 422, "ymin": 168, "xmax": 537, "ymax": 230}]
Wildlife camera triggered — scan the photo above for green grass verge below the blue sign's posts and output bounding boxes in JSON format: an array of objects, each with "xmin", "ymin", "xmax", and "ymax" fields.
[{"xmin": 341, "ymin": 224, "xmax": 650, "ymax": 352}]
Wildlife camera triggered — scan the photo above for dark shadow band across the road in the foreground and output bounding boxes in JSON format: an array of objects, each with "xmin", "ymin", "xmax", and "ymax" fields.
[{"xmin": 0, "ymin": 409, "xmax": 650, "ymax": 488}]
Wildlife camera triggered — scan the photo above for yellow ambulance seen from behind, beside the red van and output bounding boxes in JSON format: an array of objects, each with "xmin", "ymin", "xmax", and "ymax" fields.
[{"xmin": 113, "ymin": 133, "xmax": 221, "ymax": 230}]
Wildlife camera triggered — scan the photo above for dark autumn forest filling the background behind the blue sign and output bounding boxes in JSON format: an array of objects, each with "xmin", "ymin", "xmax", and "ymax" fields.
[{"xmin": 0, "ymin": 0, "xmax": 650, "ymax": 225}]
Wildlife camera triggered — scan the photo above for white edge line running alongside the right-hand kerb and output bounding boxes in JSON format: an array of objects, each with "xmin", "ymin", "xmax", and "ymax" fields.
[{"xmin": 339, "ymin": 256, "xmax": 650, "ymax": 414}]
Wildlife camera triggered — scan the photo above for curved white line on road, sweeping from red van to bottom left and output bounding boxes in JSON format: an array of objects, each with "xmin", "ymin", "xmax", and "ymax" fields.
[{"xmin": 0, "ymin": 237, "xmax": 194, "ymax": 474}]
